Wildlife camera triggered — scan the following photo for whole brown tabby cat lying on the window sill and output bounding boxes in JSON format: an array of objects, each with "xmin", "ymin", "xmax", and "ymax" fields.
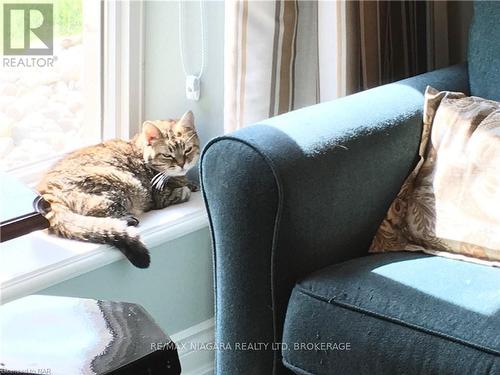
[{"xmin": 37, "ymin": 111, "xmax": 200, "ymax": 268}]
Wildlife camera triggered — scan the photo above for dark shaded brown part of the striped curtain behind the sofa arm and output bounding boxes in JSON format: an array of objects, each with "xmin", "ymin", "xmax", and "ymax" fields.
[{"xmin": 343, "ymin": 1, "xmax": 449, "ymax": 94}]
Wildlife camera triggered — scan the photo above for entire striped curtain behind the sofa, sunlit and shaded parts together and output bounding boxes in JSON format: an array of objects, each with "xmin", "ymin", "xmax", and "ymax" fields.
[{"xmin": 224, "ymin": 0, "xmax": 448, "ymax": 132}]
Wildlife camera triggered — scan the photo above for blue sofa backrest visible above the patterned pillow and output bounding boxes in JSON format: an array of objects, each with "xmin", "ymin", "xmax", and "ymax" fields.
[{"xmin": 468, "ymin": 1, "xmax": 500, "ymax": 100}]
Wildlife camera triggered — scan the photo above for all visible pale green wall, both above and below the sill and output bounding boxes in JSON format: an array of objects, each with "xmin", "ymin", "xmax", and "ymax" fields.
[{"xmin": 39, "ymin": 1, "xmax": 224, "ymax": 335}]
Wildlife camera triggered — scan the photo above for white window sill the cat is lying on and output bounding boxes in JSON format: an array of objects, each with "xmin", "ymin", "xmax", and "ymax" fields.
[{"xmin": 0, "ymin": 193, "xmax": 208, "ymax": 304}]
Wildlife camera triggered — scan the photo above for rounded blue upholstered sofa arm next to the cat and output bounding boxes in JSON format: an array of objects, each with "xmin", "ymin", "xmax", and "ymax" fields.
[{"xmin": 200, "ymin": 66, "xmax": 468, "ymax": 374}]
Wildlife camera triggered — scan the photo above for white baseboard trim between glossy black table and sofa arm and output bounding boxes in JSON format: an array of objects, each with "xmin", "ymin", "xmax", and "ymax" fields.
[{"xmin": 171, "ymin": 318, "xmax": 215, "ymax": 375}]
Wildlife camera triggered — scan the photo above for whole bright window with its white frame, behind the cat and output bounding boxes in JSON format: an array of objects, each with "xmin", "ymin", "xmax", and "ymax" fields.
[{"xmin": 0, "ymin": 0, "xmax": 143, "ymax": 185}]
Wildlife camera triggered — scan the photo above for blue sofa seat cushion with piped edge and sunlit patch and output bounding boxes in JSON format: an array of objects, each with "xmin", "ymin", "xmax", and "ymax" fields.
[{"xmin": 282, "ymin": 252, "xmax": 500, "ymax": 374}]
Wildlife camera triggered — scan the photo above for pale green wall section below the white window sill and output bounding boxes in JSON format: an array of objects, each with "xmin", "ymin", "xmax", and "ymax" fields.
[{"xmin": 37, "ymin": 229, "xmax": 213, "ymax": 335}]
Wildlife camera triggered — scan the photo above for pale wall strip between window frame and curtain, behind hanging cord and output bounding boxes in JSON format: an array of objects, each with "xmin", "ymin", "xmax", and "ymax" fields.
[{"xmin": 145, "ymin": 1, "xmax": 224, "ymax": 148}]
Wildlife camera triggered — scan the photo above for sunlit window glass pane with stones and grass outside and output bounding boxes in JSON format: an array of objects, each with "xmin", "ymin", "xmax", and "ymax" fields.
[{"xmin": 0, "ymin": 0, "xmax": 101, "ymax": 170}]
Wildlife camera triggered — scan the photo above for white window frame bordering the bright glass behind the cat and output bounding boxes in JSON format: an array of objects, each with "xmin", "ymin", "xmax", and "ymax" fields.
[{"xmin": 7, "ymin": 0, "xmax": 144, "ymax": 187}]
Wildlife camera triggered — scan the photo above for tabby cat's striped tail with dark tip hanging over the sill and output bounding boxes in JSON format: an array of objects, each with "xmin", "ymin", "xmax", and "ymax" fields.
[{"xmin": 45, "ymin": 204, "xmax": 150, "ymax": 268}]
